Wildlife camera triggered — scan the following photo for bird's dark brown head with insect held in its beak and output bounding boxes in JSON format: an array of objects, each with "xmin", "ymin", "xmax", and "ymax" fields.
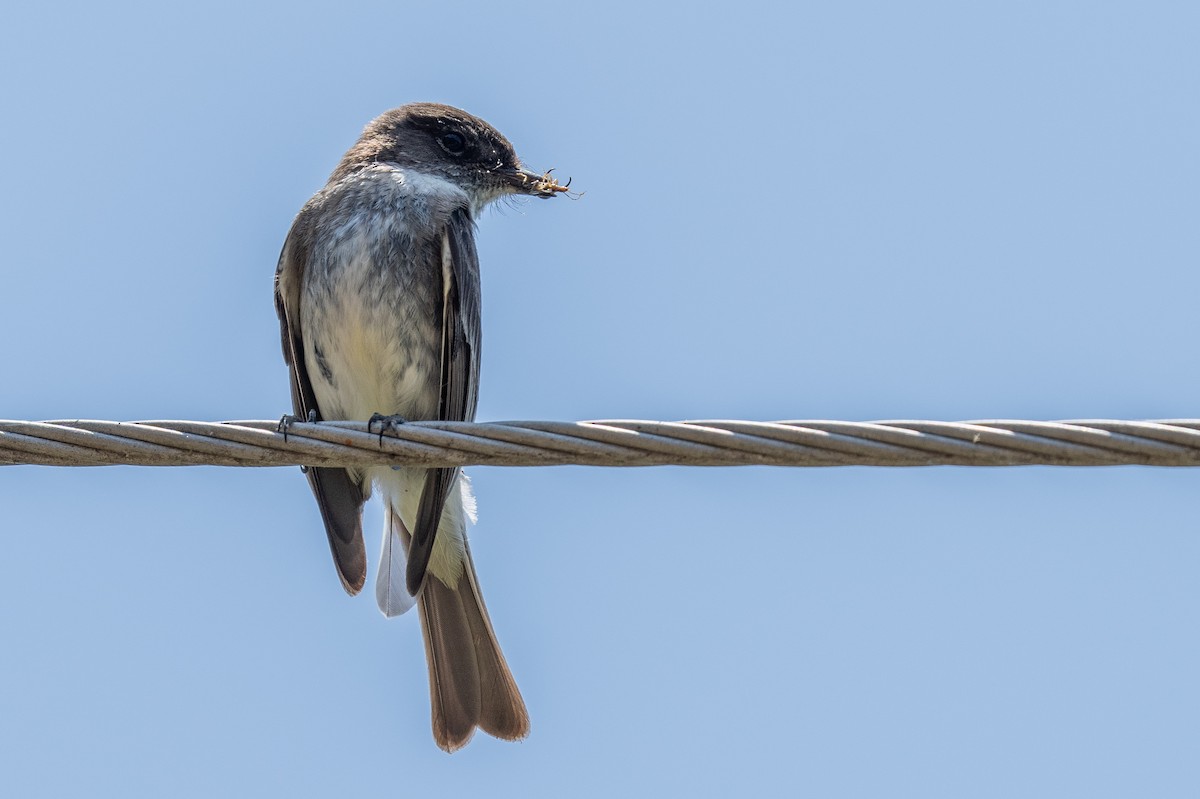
[{"xmin": 330, "ymin": 103, "xmax": 566, "ymax": 206}]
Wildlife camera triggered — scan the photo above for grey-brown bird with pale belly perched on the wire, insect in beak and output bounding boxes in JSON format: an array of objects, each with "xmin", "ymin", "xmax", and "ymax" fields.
[{"xmin": 275, "ymin": 102, "xmax": 570, "ymax": 752}]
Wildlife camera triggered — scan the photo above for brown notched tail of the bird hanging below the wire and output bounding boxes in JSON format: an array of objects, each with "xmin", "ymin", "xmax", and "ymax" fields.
[{"xmin": 416, "ymin": 537, "xmax": 529, "ymax": 752}]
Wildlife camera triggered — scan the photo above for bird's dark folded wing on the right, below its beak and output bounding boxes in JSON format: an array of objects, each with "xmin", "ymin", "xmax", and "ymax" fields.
[{"xmin": 404, "ymin": 209, "xmax": 481, "ymax": 596}]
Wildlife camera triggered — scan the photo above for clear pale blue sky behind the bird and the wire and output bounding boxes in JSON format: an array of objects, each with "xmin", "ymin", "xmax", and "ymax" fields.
[{"xmin": 0, "ymin": 0, "xmax": 1200, "ymax": 798}]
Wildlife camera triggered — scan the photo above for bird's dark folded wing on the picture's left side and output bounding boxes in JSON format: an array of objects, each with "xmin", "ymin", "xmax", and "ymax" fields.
[{"xmin": 275, "ymin": 209, "xmax": 367, "ymax": 594}]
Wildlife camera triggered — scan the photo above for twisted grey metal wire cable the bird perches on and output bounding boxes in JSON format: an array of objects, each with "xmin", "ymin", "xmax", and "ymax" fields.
[{"xmin": 0, "ymin": 419, "xmax": 1200, "ymax": 467}]
